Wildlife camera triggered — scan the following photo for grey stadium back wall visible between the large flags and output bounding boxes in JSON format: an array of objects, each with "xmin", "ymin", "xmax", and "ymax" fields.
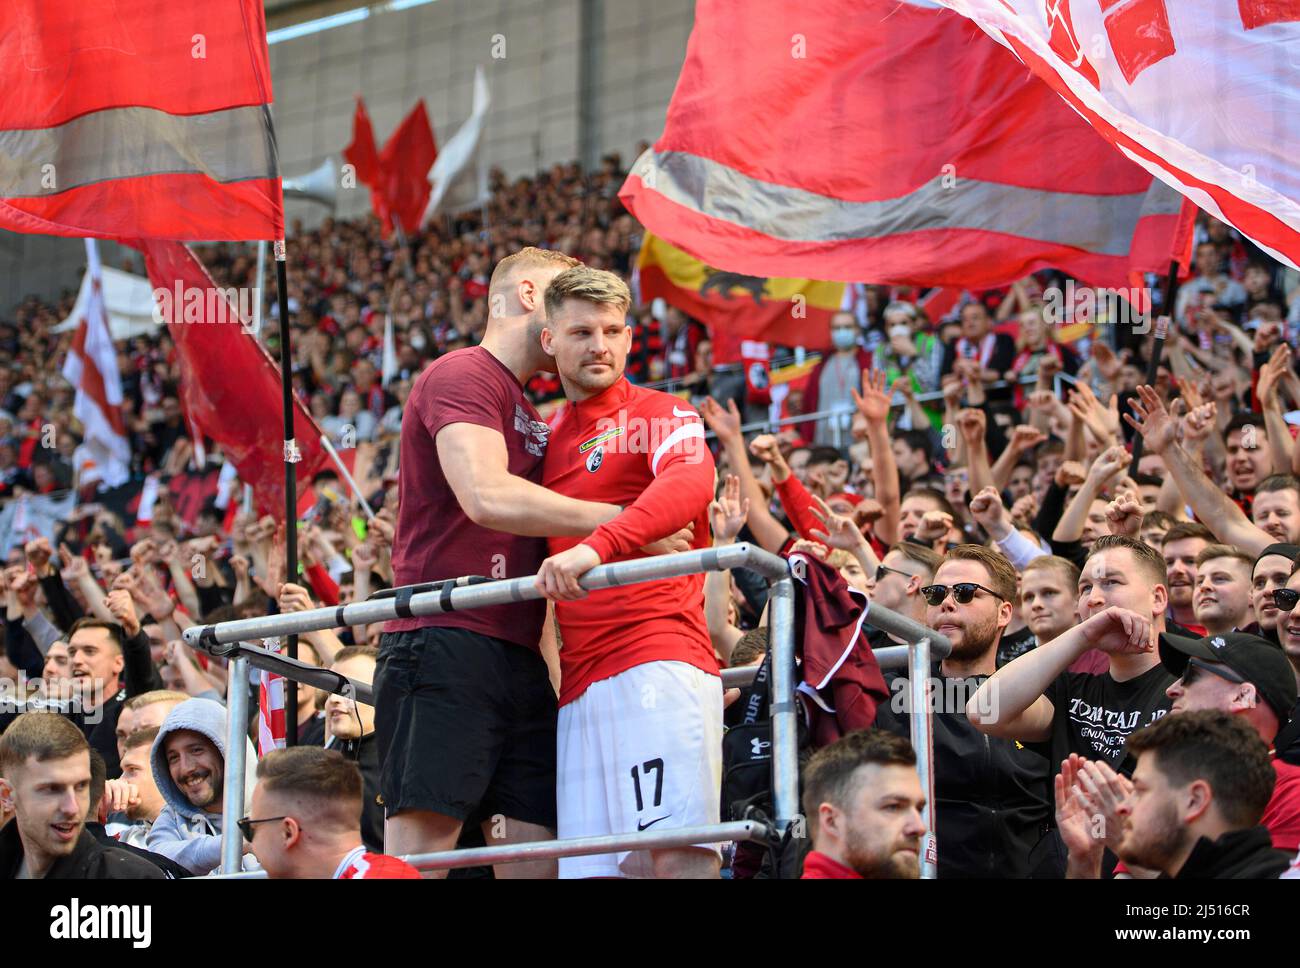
[{"xmin": 0, "ymin": 0, "xmax": 694, "ymax": 307}]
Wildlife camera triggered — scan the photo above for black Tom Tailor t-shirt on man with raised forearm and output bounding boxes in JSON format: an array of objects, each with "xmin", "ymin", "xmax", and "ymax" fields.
[{"xmin": 1045, "ymin": 664, "xmax": 1174, "ymax": 769}]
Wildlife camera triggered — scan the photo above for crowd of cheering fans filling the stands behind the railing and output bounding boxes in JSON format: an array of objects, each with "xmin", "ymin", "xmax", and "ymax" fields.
[{"xmin": 0, "ymin": 147, "xmax": 1300, "ymax": 877}]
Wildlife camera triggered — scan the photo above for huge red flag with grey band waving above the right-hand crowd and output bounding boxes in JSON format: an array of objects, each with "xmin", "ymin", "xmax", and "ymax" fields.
[{"xmin": 620, "ymin": 0, "xmax": 1179, "ymax": 290}]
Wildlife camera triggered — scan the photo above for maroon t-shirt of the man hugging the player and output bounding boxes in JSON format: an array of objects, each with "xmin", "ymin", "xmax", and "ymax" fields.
[{"xmin": 384, "ymin": 347, "xmax": 550, "ymax": 650}]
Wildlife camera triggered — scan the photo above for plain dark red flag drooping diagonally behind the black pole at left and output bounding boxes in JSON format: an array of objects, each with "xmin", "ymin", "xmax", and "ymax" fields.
[{"xmin": 133, "ymin": 240, "xmax": 329, "ymax": 518}]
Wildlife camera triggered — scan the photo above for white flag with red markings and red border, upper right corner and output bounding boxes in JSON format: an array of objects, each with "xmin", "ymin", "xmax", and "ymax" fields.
[{"xmin": 941, "ymin": 0, "xmax": 1300, "ymax": 266}]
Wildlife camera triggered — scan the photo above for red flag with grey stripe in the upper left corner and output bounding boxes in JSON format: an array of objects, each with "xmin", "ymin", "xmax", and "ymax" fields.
[{"xmin": 0, "ymin": 0, "xmax": 285, "ymax": 239}]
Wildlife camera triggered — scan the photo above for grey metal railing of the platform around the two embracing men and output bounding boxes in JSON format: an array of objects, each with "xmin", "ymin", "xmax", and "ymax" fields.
[{"xmin": 183, "ymin": 543, "xmax": 950, "ymax": 877}]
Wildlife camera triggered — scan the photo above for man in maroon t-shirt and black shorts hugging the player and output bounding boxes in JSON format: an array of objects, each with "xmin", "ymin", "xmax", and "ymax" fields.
[{"xmin": 374, "ymin": 247, "xmax": 631, "ymax": 877}]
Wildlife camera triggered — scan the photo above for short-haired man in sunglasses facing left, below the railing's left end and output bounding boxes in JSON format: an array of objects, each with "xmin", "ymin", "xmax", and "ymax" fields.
[{"xmin": 237, "ymin": 746, "xmax": 420, "ymax": 881}]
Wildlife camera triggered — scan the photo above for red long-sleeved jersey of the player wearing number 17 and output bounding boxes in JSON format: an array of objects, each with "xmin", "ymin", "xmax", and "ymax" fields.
[{"xmin": 542, "ymin": 378, "xmax": 718, "ymax": 706}]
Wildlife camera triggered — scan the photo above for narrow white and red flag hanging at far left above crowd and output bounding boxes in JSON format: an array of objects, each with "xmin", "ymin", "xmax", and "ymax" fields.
[{"xmin": 64, "ymin": 239, "xmax": 131, "ymax": 487}]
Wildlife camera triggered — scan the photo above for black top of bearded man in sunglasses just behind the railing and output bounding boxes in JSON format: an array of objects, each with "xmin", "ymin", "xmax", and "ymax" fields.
[{"xmin": 876, "ymin": 663, "xmax": 1063, "ymax": 878}]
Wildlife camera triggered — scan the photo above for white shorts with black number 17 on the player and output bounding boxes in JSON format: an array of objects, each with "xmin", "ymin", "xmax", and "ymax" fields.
[{"xmin": 555, "ymin": 661, "xmax": 723, "ymax": 877}]
